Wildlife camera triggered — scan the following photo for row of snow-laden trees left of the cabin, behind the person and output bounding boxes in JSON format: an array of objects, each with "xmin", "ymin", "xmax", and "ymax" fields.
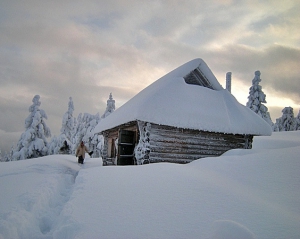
[{"xmin": 0, "ymin": 93, "xmax": 115, "ymax": 162}]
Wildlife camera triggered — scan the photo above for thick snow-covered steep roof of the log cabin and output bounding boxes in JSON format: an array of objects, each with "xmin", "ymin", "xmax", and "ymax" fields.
[{"xmin": 94, "ymin": 59, "xmax": 272, "ymax": 135}]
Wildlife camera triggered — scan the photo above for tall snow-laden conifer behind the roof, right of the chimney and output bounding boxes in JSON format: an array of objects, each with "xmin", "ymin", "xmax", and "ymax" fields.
[{"xmin": 247, "ymin": 71, "xmax": 273, "ymax": 126}]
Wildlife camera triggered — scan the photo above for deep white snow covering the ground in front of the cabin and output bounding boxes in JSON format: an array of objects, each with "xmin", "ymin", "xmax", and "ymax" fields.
[{"xmin": 0, "ymin": 131, "xmax": 300, "ymax": 239}]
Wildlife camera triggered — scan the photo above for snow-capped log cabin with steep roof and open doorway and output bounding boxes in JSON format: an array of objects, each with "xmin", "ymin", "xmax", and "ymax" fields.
[{"xmin": 95, "ymin": 59, "xmax": 272, "ymax": 165}]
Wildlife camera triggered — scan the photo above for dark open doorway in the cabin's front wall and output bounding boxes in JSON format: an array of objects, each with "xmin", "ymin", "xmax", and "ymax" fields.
[{"xmin": 117, "ymin": 130, "xmax": 135, "ymax": 165}]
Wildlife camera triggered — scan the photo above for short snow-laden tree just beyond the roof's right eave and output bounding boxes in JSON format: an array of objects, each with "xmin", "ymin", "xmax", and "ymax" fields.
[{"xmin": 273, "ymin": 107, "xmax": 295, "ymax": 131}]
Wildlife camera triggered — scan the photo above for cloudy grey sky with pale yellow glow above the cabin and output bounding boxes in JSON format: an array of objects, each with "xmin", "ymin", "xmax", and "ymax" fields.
[{"xmin": 0, "ymin": 0, "xmax": 300, "ymax": 151}]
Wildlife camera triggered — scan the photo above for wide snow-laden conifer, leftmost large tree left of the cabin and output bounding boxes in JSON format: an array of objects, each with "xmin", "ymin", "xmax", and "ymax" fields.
[{"xmin": 13, "ymin": 95, "xmax": 51, "ymax": 160}]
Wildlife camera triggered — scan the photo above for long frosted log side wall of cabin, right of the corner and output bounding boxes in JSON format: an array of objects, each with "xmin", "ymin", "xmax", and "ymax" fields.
[{"xmin": 149, "ymin": 124, "xmax": 253, "ymax": 163}]
